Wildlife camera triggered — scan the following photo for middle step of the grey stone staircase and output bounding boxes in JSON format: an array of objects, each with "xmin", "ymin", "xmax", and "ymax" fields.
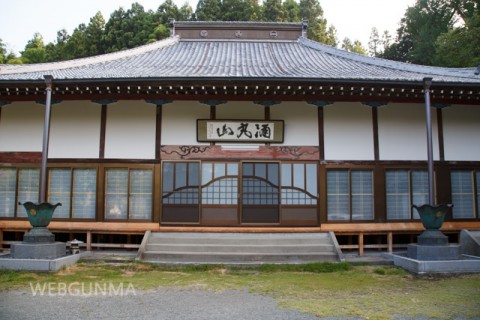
[{"xmin": 146, "ymin": 243, "xmax": 334, "ymax": 254}]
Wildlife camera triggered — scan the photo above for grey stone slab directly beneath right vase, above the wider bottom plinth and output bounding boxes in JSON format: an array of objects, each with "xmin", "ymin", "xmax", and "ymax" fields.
[{"xmin": 407, "ymin": 243, "xmax": 460, "ymax": 261}]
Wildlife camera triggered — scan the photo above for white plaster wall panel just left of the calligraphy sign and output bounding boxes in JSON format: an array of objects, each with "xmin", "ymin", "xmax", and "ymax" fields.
[{"xmin": 162, "ymin": 101, "xmax": 210, "ymax": 145}]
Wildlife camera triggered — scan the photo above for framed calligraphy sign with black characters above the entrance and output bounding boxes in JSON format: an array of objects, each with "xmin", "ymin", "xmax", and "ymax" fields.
[{"xmin": 197, "ymin": 119, "xmax": 283, "ymax": 143}]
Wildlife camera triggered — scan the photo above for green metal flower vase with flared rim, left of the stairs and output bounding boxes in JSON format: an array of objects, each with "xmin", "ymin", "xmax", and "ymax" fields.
[{"xmin": 19, "ymin": 201, "xmax": 62, "ymax": 242}]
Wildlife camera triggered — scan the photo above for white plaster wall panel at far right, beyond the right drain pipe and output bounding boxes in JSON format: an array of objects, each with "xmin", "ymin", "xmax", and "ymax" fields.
[{"xmin": 442, "ymin": 105, "xmax": 480, "ymax": 161}]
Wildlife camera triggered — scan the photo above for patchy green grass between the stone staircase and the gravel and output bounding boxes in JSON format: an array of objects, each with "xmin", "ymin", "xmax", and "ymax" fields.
[{"xmin": 0, "ymin": 261, "xmax": 480, "ymax": 319}]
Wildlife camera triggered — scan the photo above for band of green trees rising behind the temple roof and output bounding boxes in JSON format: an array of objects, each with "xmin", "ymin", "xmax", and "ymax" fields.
[{"xmin": 5, "ymin": 0, "xmax": 480, "ymax": 67}]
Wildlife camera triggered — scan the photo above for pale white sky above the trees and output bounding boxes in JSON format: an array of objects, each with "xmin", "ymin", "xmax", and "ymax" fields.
[{"xmin": 0, "ymin": 0, "xmax": 415, "ymax": 53}]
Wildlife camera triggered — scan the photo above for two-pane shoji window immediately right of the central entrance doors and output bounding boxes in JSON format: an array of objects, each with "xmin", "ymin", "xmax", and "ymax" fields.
[{"xmin": 327, "ymin": 170, "xmax": 373, "ymax": 221}]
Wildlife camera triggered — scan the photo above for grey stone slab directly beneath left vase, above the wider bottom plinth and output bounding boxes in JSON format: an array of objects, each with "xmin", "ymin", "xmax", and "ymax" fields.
[{"xmin": 10, "ymin": 242, "xmax": 67, "ymax": 259}]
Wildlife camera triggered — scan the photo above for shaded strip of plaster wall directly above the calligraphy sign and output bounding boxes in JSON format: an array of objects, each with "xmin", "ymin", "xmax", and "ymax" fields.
[{"xmin": 217, "ymin": 101, "xmax": 264, "ymax": 120}]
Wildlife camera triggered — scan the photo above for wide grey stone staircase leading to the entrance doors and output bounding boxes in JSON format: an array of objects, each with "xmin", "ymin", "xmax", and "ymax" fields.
[{"xmin": 137, "ymin": 231, "xmax": 344, "ymax": 265}]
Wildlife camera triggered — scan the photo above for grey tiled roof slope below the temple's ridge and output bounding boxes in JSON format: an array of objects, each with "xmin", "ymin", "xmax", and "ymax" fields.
[{"xmin": 0, "ymin": 36, "xmax": 480, "ymax": 84}]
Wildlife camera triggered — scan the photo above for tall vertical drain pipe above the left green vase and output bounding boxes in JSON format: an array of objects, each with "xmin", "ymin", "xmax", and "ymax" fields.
[{"xmin": 39, "ymin": 75, "xmax": 53, "ymax": 203}]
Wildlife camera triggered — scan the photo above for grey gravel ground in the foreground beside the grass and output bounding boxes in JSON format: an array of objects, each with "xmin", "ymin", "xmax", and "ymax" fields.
[{"xmin": 0, "ymin": 288, "xmax": 318, "ymax": 320}]
